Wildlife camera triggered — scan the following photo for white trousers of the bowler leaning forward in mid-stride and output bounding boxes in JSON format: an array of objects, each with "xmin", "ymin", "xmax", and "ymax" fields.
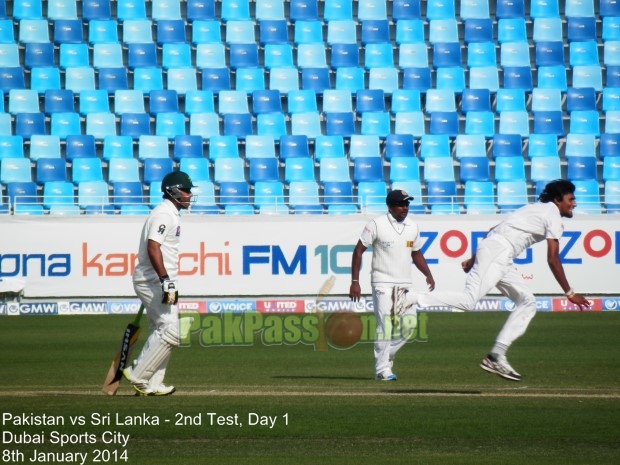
[{"xmin": 418, "ymin": 235, "xmax": 536, "ymax": 346}]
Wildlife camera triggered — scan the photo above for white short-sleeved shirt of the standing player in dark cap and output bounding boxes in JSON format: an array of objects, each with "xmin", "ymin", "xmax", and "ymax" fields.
[{"xmin": 360, "ymin": 213, "xmax": 422, "ymax": 286}]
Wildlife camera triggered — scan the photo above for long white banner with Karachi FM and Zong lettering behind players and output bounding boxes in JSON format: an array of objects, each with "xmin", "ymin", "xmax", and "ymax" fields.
[{"xmin": 0, "ymin": 215, "xmax": 620, "ymax": 300}]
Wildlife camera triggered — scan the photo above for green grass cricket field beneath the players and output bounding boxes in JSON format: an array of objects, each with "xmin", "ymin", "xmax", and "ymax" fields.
[{"xmin": 0, "ymin": 312, "xmax": 620, "ymax": 465}]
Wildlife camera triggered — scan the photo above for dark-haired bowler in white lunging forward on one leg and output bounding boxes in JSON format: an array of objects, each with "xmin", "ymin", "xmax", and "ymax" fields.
[{"xmin": 408, "ymin": 179, "xmax": 590, "ymax": 381}]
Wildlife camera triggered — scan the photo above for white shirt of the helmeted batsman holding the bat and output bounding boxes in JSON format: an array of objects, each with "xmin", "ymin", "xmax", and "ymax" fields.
[{"xmin": 133, "ymin": 199, "xmax": 181, "ymax": 284}]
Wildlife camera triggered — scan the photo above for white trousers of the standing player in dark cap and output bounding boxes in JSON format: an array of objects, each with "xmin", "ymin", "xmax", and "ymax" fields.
[{"xmin": 372, "ymin": 285, "xmax": 416, "ymax": 375}]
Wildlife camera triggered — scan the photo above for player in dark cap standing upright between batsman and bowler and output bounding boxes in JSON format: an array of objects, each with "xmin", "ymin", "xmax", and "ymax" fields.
[{"xmin": 349, "ymin": 190, "xmax": 435, "ymax": 381}]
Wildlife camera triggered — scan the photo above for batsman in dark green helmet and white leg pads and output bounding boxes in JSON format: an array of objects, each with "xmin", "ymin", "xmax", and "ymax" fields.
[{"xmin": 123, "ymin": 171, "xmax": 193, "ymax": 396}]
